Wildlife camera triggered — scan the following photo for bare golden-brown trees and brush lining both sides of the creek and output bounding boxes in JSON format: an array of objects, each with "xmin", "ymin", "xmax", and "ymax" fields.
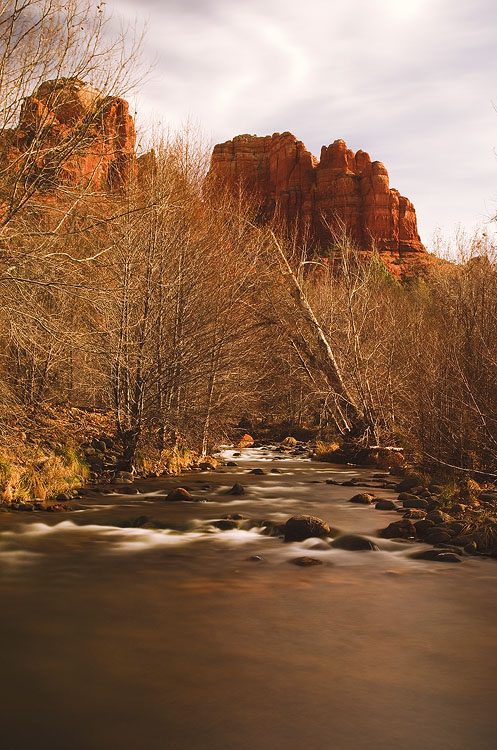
[{"xmin": 0, "ymin": 2, "xmax": 497, "ymax": 501}]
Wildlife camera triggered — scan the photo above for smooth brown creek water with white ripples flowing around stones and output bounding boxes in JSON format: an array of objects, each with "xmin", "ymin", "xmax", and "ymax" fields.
[{"xmin": 0, "ymin": 449, "xmax": 497, "ymax": 750}]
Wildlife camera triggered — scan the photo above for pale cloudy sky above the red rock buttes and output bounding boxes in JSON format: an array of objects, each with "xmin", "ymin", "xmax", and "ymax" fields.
[{"xmin": 108, "ymin": 0, "xmax": 497, "ymax": 246}]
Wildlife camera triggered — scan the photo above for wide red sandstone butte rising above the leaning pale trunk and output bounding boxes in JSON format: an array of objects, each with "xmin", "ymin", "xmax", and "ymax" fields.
[{"xmin": 209, "ymin": 133, "xmax": 427, "ymax": 275}]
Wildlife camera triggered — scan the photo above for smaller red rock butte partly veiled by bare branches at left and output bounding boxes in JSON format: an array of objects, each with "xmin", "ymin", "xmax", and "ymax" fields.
[{"xmin": 3, "ymin": 78, "xmax": 137, "ymax": 191}]
